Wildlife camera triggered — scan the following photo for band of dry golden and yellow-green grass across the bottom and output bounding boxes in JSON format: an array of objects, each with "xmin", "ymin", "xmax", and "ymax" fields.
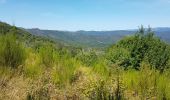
[{"xmin": 0, "ymin": 65, "xmax": 170, "ymax": 100}]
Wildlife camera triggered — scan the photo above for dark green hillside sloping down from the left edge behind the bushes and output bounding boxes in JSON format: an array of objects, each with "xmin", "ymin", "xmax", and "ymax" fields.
[{"xmin": 0, "ymin": 22, "xmax": 66, "ymax": 46}]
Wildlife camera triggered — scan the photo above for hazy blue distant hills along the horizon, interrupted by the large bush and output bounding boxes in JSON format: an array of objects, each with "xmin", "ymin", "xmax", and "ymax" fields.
[{"xmin": 27, "ymin": 27, "xmax": 170, "ymax": 47}]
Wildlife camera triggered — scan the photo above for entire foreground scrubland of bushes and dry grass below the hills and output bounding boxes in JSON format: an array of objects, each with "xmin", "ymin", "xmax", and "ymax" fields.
[{"xmin": 0, "ymin": 22, "xmax": 170, "ymax": 100}]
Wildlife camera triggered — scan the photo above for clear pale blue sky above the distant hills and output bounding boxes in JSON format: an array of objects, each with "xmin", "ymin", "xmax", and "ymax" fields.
[{"xmin": 0, "ymin": 0, "xmax": 170, "ymax": 31}]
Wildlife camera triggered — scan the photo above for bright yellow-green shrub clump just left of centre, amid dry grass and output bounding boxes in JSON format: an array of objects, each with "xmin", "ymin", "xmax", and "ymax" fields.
[{"xmin": 52, "ymin": 58, "xmax": 80, "ymax": 86}]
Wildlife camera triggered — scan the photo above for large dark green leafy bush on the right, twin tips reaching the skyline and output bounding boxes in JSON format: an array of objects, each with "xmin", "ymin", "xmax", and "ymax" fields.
[{"xmin": 110, "ymin": 27, "xmax": 170, "ymax": 72}]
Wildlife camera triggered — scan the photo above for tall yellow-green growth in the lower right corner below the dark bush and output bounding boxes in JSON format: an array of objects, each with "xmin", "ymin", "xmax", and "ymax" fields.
[{"xmin": 122, "ymin": 63, "xmax": 170, "ymax": 100}]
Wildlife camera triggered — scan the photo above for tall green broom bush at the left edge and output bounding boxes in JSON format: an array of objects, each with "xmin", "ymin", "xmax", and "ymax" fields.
[{"xmin": 0, "ymin": 33, "xmax": 26, "ymax": 68}]
